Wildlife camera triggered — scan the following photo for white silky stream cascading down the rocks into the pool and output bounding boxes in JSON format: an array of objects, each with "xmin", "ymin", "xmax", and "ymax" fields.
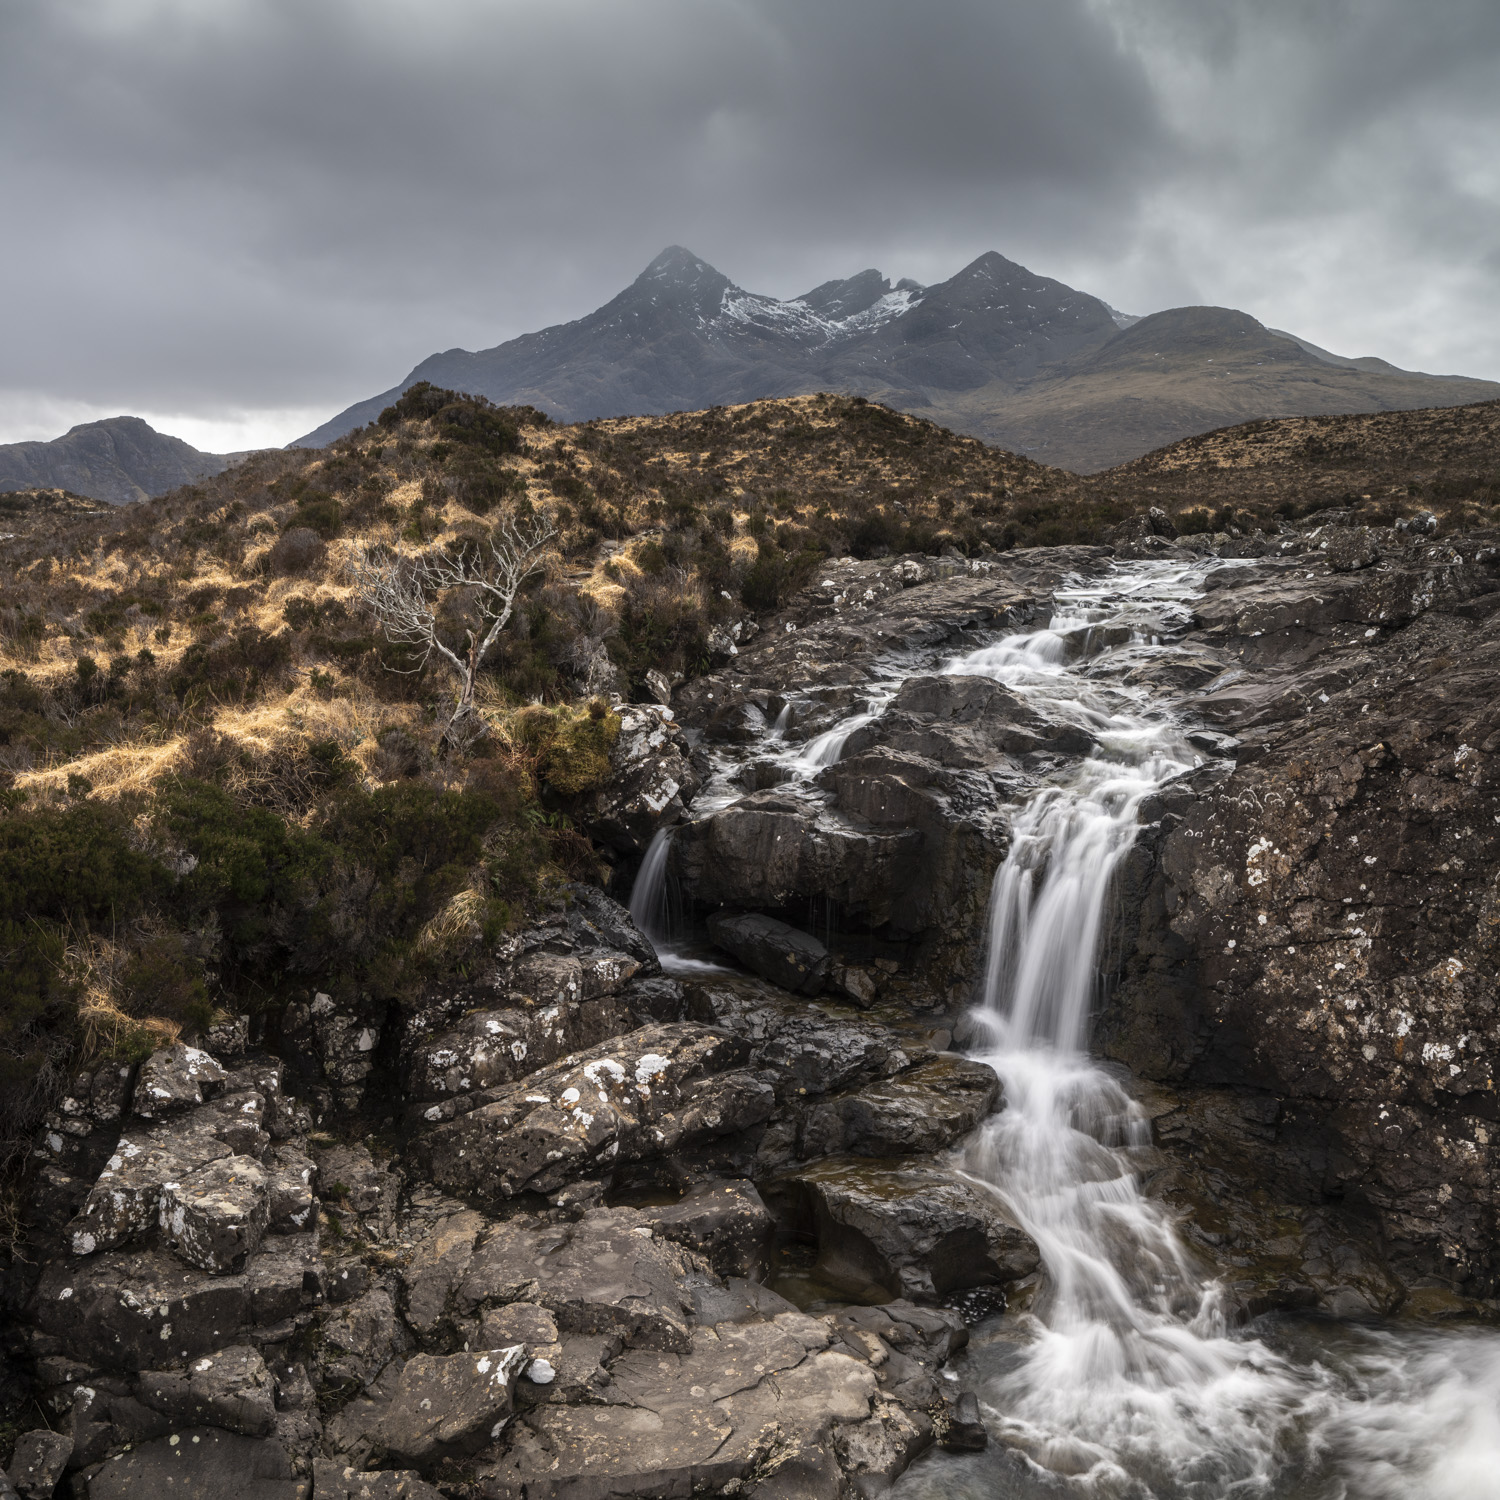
[{"xmin": 632, "ymin": 563, "xmax": 1500, "ymax": 1500}]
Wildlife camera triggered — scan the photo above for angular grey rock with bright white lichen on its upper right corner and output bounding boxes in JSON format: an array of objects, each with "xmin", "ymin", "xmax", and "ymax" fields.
[{"xmin": 380, "ymin": 1346, "xmax": 527, "ymax": 1463}]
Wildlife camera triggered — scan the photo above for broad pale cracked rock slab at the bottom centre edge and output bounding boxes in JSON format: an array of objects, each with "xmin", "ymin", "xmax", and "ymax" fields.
[{"xmin": 482, "ymin": 1314, "xmax": 878, "ymax": 1496}]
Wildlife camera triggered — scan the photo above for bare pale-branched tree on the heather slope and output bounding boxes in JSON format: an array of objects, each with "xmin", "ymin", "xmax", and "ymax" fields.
[{"xmin": 350, "ymin": 516, "xmax": 557, "ymax": 743}]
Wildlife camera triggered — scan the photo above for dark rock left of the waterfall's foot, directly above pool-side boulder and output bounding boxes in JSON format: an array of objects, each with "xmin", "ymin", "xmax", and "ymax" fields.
[{"xmin": 801, "ymin": 1056, "xmax": 1001, "ymax": 1157}]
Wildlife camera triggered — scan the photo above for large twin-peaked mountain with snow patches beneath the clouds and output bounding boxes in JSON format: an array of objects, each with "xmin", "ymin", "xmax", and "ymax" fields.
[{"xmin": 293, "ymin": 246, "xmax": 1500, "ymax": 473}]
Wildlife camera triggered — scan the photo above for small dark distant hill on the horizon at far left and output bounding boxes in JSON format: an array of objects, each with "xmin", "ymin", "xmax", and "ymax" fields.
[{"xmin": 0, "ymin": 417, "xmax": 234, "ymax": 506}]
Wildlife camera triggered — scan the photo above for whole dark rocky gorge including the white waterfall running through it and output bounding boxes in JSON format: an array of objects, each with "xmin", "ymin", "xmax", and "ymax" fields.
[{"xmin": 14, "ymin": 524, "xmax": 1500, "ymax": 1500}]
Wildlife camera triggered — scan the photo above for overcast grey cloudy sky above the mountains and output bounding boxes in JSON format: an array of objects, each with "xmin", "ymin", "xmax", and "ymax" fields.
[{"xmin": 0, "ymin": 0, "xmax": 1500, "ymax": 452}]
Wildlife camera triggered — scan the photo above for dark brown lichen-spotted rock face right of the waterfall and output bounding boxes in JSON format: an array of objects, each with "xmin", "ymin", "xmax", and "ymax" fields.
[{"xmin": 1101, "ymin": 528, "xmax": 1500, "ymax": 1299}]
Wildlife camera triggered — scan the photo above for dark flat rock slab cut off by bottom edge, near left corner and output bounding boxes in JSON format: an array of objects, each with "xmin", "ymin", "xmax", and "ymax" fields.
[{"xmin": 89, "ymin": 1427, "xmax": 312, "ymax": 1500}]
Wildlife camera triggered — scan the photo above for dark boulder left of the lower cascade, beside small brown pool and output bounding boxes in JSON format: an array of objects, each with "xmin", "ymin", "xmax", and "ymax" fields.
[{"xmin": 768, "ymin": 1158, "xmax": 1041, "ymax": 1302}]
